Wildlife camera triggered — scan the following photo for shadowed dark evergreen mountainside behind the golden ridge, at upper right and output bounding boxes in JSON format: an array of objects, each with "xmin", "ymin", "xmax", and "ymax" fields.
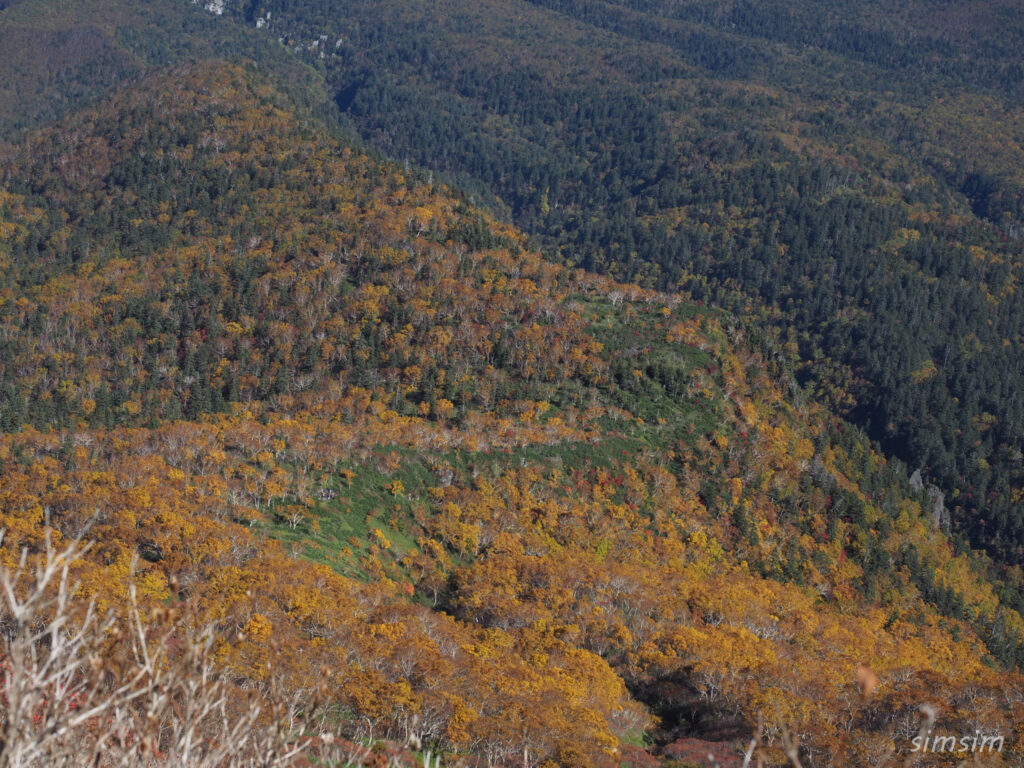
[{"xmin": 155, "ymin": 0, "xmax": 1024, "ymax": 596}]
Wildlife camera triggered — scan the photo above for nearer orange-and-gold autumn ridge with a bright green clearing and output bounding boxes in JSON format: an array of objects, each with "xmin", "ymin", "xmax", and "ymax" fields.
[{"xmin": 0, "ymin": 62, "xmax": 1024, "ymax": 768}]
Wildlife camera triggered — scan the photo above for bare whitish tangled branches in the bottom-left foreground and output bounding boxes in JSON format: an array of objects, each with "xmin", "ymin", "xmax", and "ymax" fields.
[{"xmin": 0, "ymin": 535, "xmax": 335, "ymax": 768}]
